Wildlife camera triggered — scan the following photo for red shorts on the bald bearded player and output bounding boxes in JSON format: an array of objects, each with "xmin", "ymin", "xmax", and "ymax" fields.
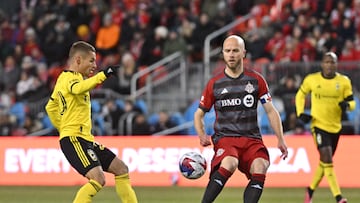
[{"xmin": 211, "ymin": 137, "xmax": 270, "ymax": 178}]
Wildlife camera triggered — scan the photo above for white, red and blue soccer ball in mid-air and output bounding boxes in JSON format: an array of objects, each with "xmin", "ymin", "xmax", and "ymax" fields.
[{"xmin": 179, "ymin": 152, "xmax": 206, "ymax": 179}]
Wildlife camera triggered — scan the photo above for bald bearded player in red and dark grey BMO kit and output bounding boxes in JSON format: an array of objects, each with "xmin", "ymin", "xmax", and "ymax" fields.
[{"xmin": 194, "ymin": 35, "xmax": 288, "ymax": 203}]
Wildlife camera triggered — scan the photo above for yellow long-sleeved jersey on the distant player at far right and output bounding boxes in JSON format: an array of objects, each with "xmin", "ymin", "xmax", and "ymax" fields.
[{"xmin": 295, "ymin": 72, "xmax": 355, "ymax": 133}]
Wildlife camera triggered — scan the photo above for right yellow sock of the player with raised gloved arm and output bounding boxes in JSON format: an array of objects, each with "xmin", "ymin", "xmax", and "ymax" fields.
[{"xmin": 115, "ymin": 173, "xmax": 137, "ymax": 203}]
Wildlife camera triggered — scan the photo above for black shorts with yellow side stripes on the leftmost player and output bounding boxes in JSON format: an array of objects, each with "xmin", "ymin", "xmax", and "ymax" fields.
[{"xmin": 60, "ymin": 136, "xmax": 116, "ymax": 176}]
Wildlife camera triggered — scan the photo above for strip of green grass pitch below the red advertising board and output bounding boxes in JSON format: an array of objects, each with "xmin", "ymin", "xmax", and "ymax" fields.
[{"xmin": 0, "ymin": 186, "xmax": 360, "ymax": 203}]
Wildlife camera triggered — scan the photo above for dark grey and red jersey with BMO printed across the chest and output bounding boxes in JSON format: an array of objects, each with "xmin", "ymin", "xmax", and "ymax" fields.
[{"xmin": 199, "ymin": 69, "xmax": 271, "ymax": 139}]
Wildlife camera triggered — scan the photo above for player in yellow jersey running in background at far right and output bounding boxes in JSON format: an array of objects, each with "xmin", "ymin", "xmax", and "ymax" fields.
[{"xmin": 295, "ymin": 52, "xmax": 355, "ymax": 203}]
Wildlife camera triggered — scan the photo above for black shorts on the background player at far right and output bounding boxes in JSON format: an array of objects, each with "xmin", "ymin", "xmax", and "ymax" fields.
[{"xmin": 313, "ymin": 127, "xmax": 340, "ymax": 154}]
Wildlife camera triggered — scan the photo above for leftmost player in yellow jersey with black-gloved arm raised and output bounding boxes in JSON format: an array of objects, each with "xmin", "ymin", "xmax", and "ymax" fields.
[{"xmin": 45, "ymin": 41, "xmax": 137, "ymax": 203}]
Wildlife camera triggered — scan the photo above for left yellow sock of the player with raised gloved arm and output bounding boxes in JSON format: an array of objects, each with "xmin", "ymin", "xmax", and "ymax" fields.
[{"xmin": 73, "ymin": 180, "xmax": 102, "ymax": 203}]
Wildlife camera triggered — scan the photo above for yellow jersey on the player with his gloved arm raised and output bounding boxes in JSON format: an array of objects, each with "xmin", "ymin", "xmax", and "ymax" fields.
[{"xmin": 45, "ymin": 71, "xmax": 106, "ymax": 141}]
